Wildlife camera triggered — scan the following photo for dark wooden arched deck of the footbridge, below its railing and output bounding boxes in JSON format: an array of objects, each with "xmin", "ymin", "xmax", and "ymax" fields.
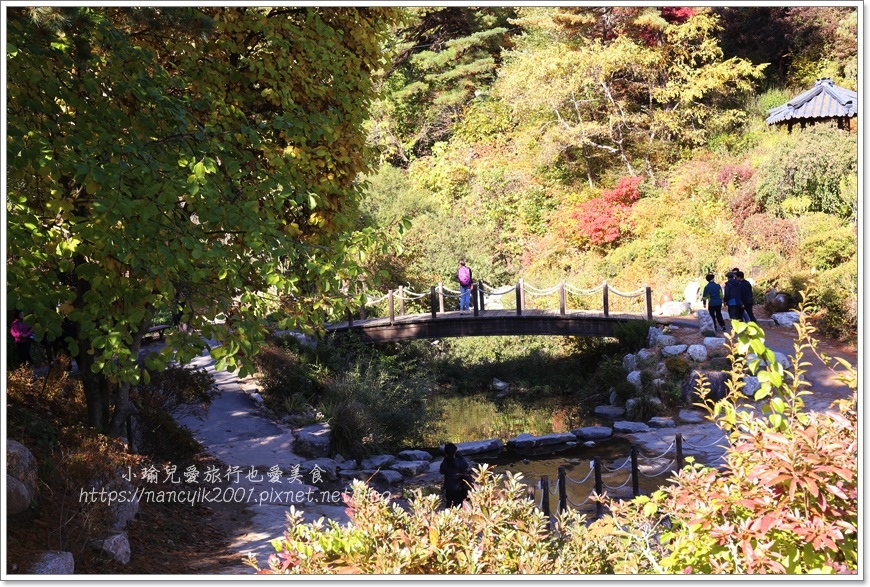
[{"xmin": 326, "ymin": 310, "xmax": 647, "ymax": 342}]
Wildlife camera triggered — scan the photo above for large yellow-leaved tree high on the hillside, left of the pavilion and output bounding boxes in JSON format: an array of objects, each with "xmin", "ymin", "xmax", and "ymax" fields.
[{"xmin": 495, "ymin": 9, "xmax": 762, "ymax": 185}]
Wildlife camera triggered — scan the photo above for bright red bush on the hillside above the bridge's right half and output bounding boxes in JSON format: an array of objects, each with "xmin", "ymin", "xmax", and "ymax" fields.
[{"xmin": 573, "ymin": 176, "xmax": 643, "ymax": 245}]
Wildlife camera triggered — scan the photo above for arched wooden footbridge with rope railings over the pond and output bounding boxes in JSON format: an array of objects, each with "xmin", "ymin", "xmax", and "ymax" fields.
[{"xmin": 326, "ymin": 280, "xmax": 652, "ymax": 342}]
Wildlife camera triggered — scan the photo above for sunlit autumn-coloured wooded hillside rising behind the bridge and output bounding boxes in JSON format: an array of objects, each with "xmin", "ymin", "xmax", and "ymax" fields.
[{"xmin": 362, "ymin": 7, "xmax": 858, "ymax": 339}]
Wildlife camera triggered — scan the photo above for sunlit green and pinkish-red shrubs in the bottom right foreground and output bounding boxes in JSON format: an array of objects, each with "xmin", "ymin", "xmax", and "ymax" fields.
[{"xmin": 247, "ymin": 304, "xmax": 858, "ymax": 574}]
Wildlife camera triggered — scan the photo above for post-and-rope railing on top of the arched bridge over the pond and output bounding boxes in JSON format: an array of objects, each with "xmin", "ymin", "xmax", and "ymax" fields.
[{"xmin": 348, "ymin": 279, "xmax": 652, "ymax": 324}]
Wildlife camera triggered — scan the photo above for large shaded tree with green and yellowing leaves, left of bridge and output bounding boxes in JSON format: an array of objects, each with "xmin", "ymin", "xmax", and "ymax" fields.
[{"xmin": 7, "ymin": 7, "xmax": 395, "ymax": 434}]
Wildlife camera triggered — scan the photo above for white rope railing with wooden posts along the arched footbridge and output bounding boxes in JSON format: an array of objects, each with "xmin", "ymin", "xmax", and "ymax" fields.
[{"xmin": 348, "ymin": 279, "xmax": 652, "ymax": 326}]
